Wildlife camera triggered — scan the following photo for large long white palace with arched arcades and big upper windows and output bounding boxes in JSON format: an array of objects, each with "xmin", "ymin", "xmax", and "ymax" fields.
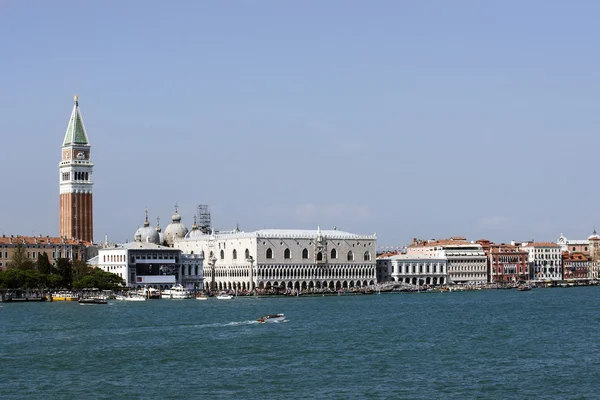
[{"xmin": 173, "ymin": 229, "xmax": 377, "ymax": 292}]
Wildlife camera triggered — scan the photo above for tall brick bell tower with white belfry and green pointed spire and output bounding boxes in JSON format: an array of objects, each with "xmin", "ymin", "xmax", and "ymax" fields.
[{"xmin": 58, "ymin": 95, "xmax": 94, "ymax": 242}]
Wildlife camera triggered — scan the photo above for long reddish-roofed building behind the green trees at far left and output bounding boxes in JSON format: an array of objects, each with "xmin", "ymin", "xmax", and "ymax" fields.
[{"xmin": 0, "ymin": 235, "xmax": 90, "ymax": 270}]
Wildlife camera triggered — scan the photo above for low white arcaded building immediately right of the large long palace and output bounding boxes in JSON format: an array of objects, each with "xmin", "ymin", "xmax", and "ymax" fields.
[{"xmin": 377, "ymin": 254, "xmax": 448, "ymax": 286}]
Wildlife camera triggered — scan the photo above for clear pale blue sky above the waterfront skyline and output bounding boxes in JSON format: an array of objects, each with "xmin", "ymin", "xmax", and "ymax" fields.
[{"xmin": 0, "ymin": 0, "xmax": 600, "ymax": 247}]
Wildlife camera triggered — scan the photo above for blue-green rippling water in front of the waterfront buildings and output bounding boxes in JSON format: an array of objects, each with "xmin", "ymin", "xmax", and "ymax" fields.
[{"xmin": 0, "ymin": 287, "xmax": 600, "ymax": 399}]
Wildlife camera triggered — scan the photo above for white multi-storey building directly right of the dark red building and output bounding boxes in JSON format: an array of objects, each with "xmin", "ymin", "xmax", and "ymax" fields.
[{"xmin": 521, "ymin": 242, "xmax": 562, "ymax": 281}]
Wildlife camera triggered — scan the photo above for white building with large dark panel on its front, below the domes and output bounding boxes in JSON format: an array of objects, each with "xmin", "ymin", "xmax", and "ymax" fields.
[{"xmin": 88, "ymin": 242, "xmax": 184, "ymax": 289}]
